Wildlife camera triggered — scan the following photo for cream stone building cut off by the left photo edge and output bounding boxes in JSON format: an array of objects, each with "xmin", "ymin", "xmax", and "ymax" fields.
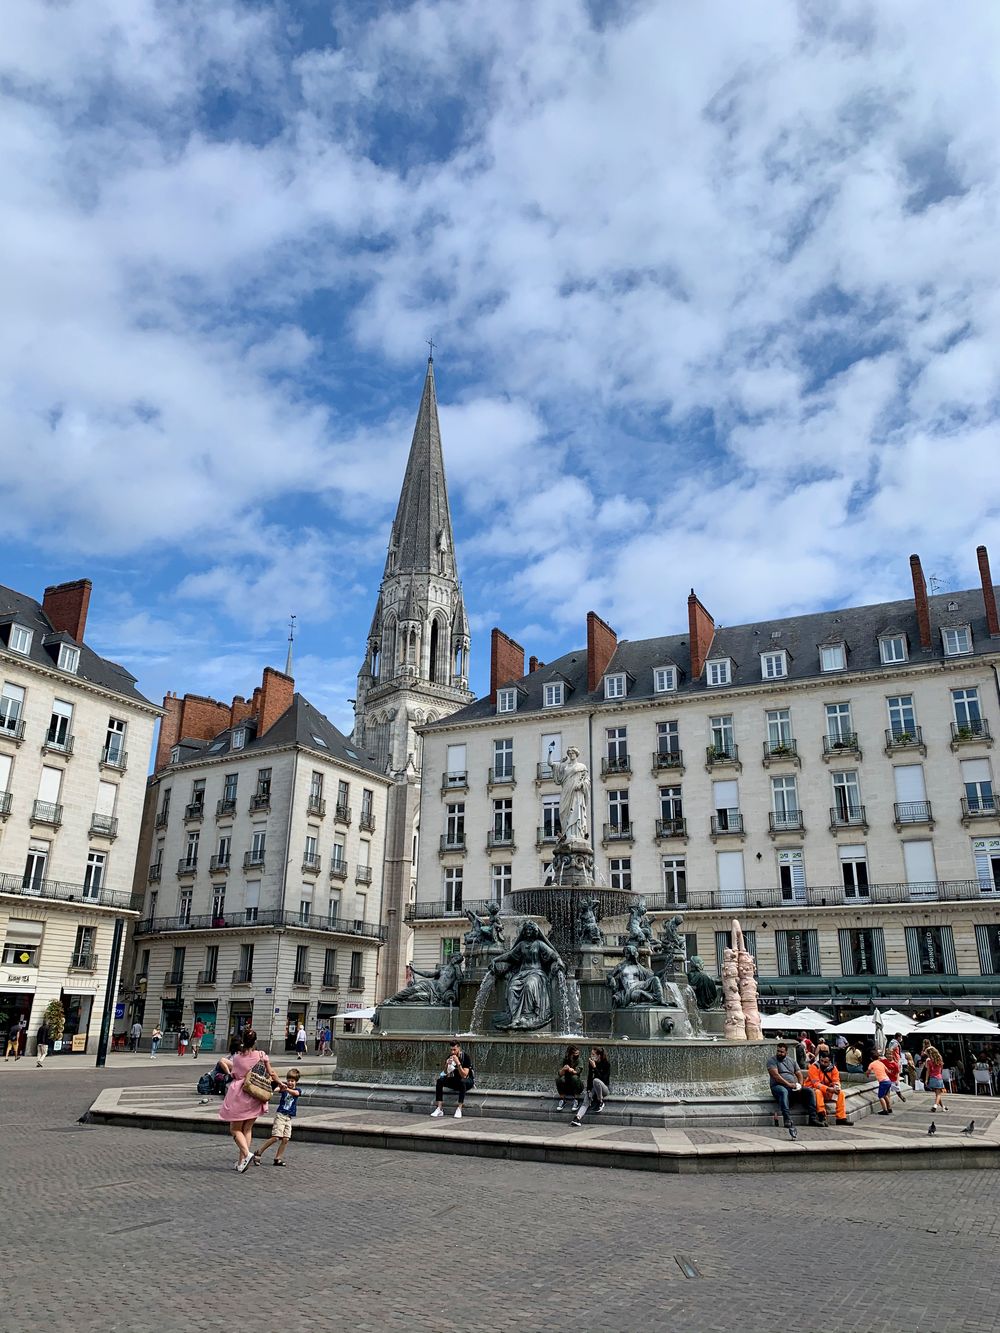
[{"xmin": 0, "ymin": 580, "xmax": 160, "ymax": 1053}]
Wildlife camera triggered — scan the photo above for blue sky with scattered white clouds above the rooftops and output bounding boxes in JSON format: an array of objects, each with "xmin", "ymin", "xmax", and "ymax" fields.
[{"xmin": 0, "ymin": 0, "xmax": 1000, "ymax": 729}]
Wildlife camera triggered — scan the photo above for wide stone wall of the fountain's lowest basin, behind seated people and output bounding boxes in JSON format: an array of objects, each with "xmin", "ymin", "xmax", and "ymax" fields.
[{"xmin": 336, "ymin": 1033, "xmax": 775, "ymax": 1098}]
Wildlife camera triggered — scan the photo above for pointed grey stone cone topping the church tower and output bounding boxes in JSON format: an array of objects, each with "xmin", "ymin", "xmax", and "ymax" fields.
[{"xmin": 385, "ymin": 356, "xmax": 455, "ymax": 576}]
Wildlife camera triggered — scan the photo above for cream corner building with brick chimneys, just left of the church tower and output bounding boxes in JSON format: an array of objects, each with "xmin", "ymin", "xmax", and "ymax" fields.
[{"xmin": 129, "ymin": 668, "xmax": 392, "ymax": 1052}]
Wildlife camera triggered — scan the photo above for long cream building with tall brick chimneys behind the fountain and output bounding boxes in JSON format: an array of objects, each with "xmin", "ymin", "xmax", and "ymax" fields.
[{"xmin": 409, "ymin": 548, "xmax": 1000, "ymax": 1009}]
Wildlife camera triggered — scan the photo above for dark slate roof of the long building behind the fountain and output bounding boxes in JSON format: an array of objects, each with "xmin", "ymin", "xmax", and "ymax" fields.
[{"xmin": 431, "ymin": 588, "xmax": 1000, "ymax": 729}]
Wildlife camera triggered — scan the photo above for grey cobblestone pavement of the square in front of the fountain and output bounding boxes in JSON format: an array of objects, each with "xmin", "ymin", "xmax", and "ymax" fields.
[{"xmin": 0, "ymin": 1062, "xmax": 1000, "ymax": 1333}]
